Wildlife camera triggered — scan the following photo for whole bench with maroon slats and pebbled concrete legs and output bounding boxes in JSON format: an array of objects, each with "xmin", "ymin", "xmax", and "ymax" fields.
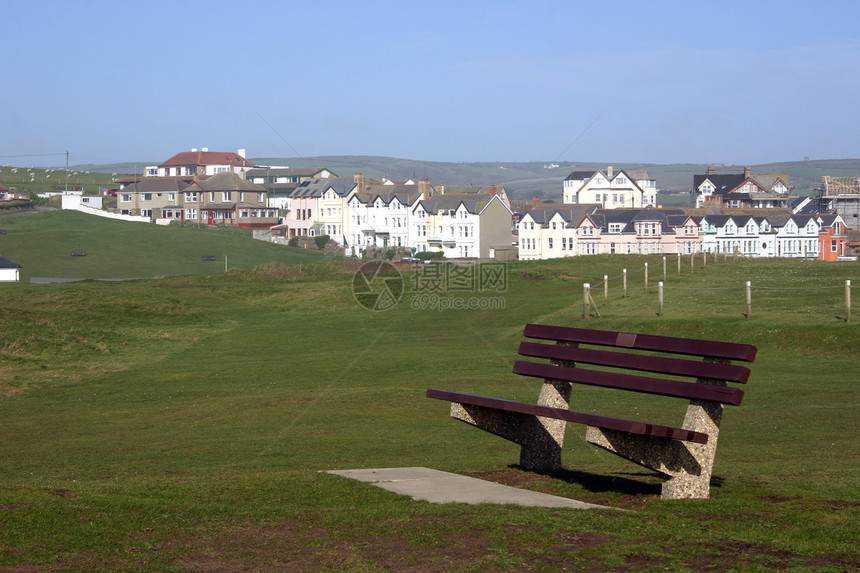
[{"xmin": 427, "ymin": 324, "xmax": 756, "ymax": 499}]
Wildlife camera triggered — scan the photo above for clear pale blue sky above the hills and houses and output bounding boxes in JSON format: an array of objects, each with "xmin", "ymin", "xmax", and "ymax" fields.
[{"xmin": 0, "ymin": 0, "xmax": 860, "ymax": 166}]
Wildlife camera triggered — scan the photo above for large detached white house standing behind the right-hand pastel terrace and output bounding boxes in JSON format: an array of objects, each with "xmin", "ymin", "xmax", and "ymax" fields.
[{"xmin": 562, "ymin": 165, "xmax": 657, "ymax": 209}]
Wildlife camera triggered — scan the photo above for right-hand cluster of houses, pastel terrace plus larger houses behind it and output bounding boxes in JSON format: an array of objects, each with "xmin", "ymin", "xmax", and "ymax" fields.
[{"xmin": 518, "ymin": 162, "xmax": 848, "ymax": 260}]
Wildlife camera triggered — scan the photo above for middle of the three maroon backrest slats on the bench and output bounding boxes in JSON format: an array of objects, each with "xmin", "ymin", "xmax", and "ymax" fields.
[{"xmin": 519, "ymin": 342, "xmax": 750, "ymax": 384}]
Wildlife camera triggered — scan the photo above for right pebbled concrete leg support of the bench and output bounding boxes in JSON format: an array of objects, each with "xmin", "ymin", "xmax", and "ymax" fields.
[{"xmin": 585, "ymin": 400, "xmax": 723, "ymax": 499}]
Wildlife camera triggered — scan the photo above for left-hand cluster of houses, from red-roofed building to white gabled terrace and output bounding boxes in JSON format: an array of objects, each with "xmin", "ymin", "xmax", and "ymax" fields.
[{"xmin": 117, "ymin": 148, "xmax": 513, "ymax": 258}]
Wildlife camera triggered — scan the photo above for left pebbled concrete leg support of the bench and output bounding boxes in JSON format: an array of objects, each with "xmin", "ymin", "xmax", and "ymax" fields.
[{"xmin": 451, "ymin": 380, "xmax": 571, "ymax": 470}]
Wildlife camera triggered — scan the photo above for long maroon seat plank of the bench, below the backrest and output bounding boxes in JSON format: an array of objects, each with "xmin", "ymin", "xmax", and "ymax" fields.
[{"xmin": 427, "ymin": 389, "xmax": 708, "ymax": 444}]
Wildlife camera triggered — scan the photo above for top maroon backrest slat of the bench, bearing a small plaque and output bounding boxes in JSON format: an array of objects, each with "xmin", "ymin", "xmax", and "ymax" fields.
[{"xmin": 524, "ymin": 324, "xmax": 757, "ymax": 362}]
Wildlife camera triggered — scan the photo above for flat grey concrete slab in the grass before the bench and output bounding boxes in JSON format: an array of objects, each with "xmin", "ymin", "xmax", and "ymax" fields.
[{"xmin": 326, "ymin": 467, "xmax": 611, "ymax": 509}]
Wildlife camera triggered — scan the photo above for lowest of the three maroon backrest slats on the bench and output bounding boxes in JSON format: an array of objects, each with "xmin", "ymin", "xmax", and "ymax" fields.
[{"xmin": 514, "ymin": 360, "xmax": 744, "ymax": 406}]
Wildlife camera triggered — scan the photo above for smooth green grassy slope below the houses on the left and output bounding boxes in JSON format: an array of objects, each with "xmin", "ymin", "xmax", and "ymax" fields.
[{"xmin": 0, "ymin": 211, "xmax": 323, "ymax": 282}]
